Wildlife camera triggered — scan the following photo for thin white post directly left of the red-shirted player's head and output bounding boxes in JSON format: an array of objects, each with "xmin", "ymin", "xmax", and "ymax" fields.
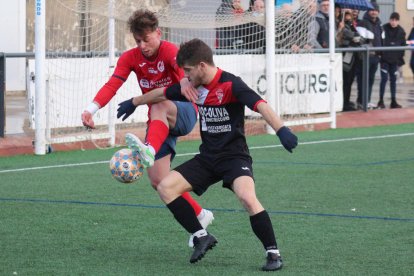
[{"xmin": 108, "ymin": 0, "xmax": 116, "ymax": 146}]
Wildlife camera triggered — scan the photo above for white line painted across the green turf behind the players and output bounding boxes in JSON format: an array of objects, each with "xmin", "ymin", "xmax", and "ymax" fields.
[{"xmin": 0, "ymin": 133, "xmax": 414, "ymax": 173}]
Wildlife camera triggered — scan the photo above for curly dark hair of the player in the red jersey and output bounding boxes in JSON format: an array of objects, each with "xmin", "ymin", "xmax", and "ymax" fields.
[{"xmin": 128, "ymin": 9, "xmax": 158, "ymax": 35}]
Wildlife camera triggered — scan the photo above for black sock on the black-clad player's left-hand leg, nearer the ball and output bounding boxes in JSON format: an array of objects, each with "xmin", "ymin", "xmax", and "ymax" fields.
[{"xmin": 167, "ymin": 196, "xmax": 203, "ymax": 234}]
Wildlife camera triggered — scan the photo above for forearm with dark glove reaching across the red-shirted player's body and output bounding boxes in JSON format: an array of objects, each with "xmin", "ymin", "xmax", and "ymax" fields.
[{"xmin": 116, "ymin": 88, "xmax": 166, "ymax": 121}]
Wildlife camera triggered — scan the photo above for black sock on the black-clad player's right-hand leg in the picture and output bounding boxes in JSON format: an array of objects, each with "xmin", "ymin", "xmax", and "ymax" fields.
[{"xmin": 250, "ymin": 210, "xmax": 277, "ymax": 250}]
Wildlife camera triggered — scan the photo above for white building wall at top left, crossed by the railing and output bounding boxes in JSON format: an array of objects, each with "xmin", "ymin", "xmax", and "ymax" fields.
[{"xmin": 0, "ymin": 0, "xmax": 26, "ymax": 91}]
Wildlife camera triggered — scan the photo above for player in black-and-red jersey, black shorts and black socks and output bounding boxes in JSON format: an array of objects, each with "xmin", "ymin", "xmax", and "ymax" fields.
[{"xmin": 118, "ymin": 39, "xmax": 297, "ymax": 271}]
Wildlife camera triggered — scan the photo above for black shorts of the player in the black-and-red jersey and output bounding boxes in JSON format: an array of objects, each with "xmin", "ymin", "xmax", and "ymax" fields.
[{"xmin": 174, "ymin": 154, "xmax": 254, "ymax": 196}]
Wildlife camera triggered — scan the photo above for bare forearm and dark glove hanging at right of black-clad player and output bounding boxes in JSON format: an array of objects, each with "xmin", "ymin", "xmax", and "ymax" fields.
[{"xmin": 257, "ymin": 102, "xmax": 298, "ymax": 152}]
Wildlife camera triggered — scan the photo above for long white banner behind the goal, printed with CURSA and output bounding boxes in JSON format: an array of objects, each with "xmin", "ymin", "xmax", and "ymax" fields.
[{"xmin": 28, "ymin": 53, "xmax": 342, "ymax": 128}]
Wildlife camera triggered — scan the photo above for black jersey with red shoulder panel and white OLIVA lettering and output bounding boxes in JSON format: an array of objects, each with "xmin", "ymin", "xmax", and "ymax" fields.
[{"xmin": 165, "ymin": 69, "xmax": 264, "ymax": 159}]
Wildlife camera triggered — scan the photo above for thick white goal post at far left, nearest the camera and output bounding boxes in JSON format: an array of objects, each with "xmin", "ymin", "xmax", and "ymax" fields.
[{"xmin": 35, "ymin": 0, "xmax": 46, "ymax": 155}]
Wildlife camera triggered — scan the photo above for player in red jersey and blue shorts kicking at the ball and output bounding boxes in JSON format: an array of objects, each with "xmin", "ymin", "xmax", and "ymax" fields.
[{"xmin": 82, "ymin": 10, "xmax": 214, "ymax": 246}]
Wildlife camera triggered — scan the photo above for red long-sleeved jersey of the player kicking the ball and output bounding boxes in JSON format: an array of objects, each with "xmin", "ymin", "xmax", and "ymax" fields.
[{"xmin": 94, "ymin": 40, "xmax": 184, "ymax": 107}]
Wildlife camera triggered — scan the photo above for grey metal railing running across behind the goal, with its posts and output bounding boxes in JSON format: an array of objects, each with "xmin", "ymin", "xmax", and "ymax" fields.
[{"xmin": 0, "ymin": 45, "xmax": 414, "ymax": 137}]
